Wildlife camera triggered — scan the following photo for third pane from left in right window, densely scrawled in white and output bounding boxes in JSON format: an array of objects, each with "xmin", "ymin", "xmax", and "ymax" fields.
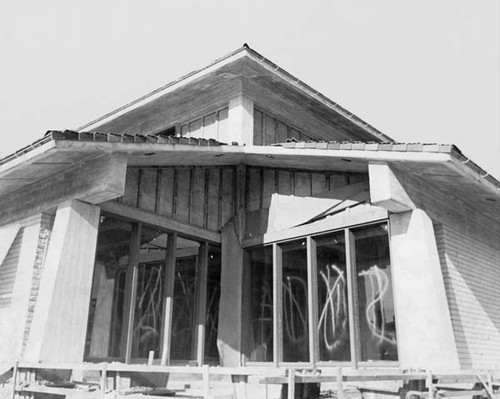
[{"xmin": 315, "ymin": 231, "xmax": 351, "ymax": 361}]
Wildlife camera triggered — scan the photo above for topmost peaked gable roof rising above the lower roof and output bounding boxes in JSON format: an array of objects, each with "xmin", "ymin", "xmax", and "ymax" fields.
[{"xmin": 77, "ymin": 44, "xmax": 393, "ymax": 142}]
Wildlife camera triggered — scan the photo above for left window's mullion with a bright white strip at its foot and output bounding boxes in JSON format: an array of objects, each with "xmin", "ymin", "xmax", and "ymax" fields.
[{"xmin": 161, "ymin": 233, "xmax": 177, "ymax": 366}]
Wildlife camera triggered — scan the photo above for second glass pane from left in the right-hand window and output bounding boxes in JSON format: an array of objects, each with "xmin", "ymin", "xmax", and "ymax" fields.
[{"xmin": 280, "ymin": 239, "xmax": 309, "ymax": 362}]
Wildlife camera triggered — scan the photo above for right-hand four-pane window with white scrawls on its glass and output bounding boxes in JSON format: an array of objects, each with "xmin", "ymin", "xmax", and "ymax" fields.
[{"xmin": 244, "ymin": 222, "xmax": 398, "ymax": 363}]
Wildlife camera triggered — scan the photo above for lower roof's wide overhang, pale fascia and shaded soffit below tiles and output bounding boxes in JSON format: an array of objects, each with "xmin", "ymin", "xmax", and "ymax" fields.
[{"xmin": 0, "ymin": 139, "xmax": 500, "ymax": 223}]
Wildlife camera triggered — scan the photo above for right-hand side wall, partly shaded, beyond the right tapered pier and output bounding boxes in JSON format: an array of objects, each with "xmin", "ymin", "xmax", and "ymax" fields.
[{"xmin": 392, "ymin": 170, "xmax": 500, "ymax": 369}]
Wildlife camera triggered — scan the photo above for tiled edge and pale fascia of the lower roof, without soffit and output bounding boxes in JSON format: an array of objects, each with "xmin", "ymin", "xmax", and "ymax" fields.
[{"xmin": 0, "ymin": 131, "xmax": 500, "ymax": 203}]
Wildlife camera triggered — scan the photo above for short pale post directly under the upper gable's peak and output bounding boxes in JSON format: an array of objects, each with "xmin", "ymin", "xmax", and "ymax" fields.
[{"xmin": 228, "ymin": 95, "xmax": 254, "ymax": 145}]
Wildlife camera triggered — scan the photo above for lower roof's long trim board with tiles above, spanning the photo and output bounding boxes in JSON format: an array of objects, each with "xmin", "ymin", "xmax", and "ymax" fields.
[{"xmin": 0, "ymin": 132, "xmax": 500, "ymax": 205}]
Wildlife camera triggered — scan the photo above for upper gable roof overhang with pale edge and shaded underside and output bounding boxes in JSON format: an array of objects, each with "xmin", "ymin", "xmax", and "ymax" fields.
[{"xmin": 77, "ymin": 46, "xmax": 392, "ymax": 141}]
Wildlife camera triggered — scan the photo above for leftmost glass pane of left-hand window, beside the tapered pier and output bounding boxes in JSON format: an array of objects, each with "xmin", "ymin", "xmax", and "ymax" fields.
[{"xmin": 85, "ymin": 216, "xmax": 132, "ymax": 359}]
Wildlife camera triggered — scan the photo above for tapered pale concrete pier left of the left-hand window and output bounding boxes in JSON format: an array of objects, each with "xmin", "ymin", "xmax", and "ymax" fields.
[{"xmin": 25, "ymin": 200, "xmax": 100, "ymax": 362}]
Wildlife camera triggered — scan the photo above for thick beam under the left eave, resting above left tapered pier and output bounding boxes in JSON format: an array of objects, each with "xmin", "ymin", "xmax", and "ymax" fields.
[{"xmin": 0, "ymin": 153, "xmax": 127, "ymax": 228}]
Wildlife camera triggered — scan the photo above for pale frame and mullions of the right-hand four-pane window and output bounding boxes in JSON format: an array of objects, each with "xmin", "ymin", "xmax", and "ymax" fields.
[{"xmin": 243, "ymin": 217, "xmax": 400, "ymax": 368}]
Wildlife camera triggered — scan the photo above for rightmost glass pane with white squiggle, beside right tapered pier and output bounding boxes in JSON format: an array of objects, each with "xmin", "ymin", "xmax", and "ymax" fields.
[{"xmin": 352, "ymin": 223, "xmax": 398, "ymax": 361}]
